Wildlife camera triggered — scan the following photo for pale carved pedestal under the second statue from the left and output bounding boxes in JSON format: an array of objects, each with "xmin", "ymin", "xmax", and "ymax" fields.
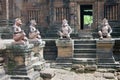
[{"xmin": 30, "ymin": 41, "xmax": 45, "ymax": 71}]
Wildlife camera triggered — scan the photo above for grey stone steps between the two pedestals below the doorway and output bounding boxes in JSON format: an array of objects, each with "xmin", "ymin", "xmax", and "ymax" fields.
[{"xmin": 73, "ymin": 39, "xmax": 96, "ymax": 65}]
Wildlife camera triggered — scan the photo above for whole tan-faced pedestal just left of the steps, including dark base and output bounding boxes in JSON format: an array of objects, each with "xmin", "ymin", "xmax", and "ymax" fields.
[{"xmin": 56, "ymin": 39, "xmax": 74, "ymax": 63}]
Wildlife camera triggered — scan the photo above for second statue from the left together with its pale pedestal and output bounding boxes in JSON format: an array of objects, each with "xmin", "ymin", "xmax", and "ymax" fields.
[{"xmin": 29, "ymin": 20, "xmax": 45, "ymax": 71}]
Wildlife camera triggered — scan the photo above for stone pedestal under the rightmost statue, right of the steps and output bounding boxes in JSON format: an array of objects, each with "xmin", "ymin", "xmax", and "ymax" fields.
[{"xmin": 96, "ymin": 39, "xmax": 115, "ymax": 64}]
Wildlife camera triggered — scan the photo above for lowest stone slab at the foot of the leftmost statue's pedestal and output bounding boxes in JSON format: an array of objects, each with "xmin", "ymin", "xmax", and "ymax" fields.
[{"xmin": 11, "ymin": 72, "xmax": 42, "ymax": 80}]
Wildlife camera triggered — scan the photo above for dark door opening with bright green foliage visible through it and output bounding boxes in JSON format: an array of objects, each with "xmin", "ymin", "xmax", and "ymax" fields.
[{"xmin": 80, "ymin": 5, "xmax": 93, "ymax": 30}]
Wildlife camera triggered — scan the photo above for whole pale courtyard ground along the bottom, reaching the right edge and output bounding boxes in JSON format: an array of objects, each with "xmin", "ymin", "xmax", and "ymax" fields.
[{"xmin": 40, "ymin": 62, "xmax": 120, "ymax": 80}]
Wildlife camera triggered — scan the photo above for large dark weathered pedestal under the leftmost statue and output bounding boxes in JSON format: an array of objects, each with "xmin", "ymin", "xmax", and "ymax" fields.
[{"xmin": 6, "ymin": 44, "xmax": 40, "ymax": 80}]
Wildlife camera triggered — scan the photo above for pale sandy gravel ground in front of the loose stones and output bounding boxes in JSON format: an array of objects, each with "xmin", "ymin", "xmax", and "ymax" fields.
[{"xmin": 41, "ymin": 68, "xmax": 118, "ymax": 80}]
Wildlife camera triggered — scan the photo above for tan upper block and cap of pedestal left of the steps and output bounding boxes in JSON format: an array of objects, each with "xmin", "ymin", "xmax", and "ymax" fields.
[{"xmin": 56, "ymin": 40, "xmax": 74, "ymax": 58}]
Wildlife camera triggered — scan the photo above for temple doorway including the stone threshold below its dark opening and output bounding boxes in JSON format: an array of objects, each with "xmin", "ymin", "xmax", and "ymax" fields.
[{"xmin": 79, "ymin": 4, "xmax": 93, "ymax": 39}]
